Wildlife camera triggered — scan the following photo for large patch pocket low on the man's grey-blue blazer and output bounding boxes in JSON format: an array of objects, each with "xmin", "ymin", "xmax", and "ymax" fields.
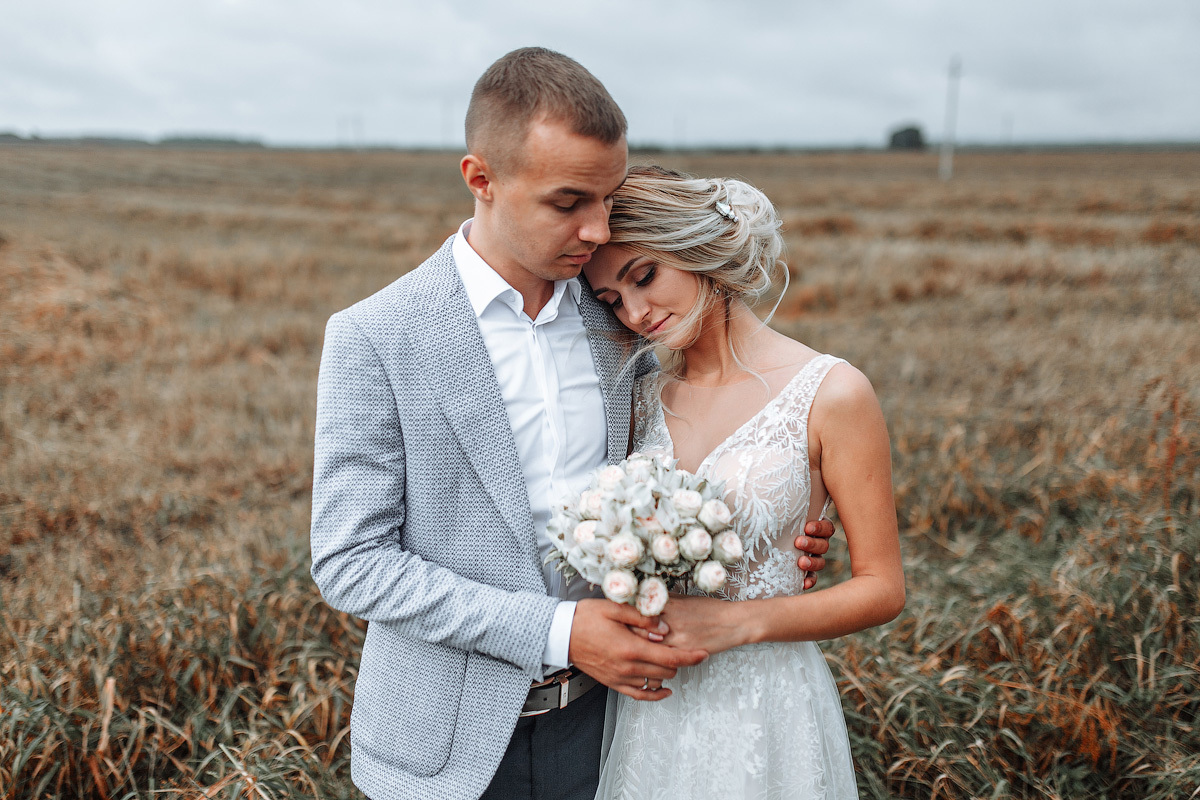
[{"xmin": 350, "ymin": 622, "xmax": 467, "ymax": 777}]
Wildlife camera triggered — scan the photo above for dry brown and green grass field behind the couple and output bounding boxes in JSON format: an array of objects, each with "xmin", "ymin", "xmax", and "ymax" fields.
[{"xmin": 0, "ymin": 146, "xmax": 1200, "ymax": 800}]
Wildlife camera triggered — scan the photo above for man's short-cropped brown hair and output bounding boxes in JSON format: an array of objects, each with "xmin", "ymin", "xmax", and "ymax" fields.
[{"xmin": 467, "ymin": 47, "xmax": 628, "ymax": 176}]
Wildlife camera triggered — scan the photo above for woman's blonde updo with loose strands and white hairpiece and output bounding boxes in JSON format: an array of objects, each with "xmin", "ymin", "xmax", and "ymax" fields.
[{"xmin": 608, "ymin": 167, "xmax": 788, "ymax": 378}]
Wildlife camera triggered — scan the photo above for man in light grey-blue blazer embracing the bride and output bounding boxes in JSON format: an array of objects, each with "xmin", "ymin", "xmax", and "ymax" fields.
[{"xmin": 312, "ymin": 48, "xmax": 832, "ymax": 800}]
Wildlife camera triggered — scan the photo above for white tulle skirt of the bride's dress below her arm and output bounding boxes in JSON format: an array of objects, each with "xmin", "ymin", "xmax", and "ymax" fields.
[{"xmin": 596, "ymin": 642, "xmax": 858, "ymax": 800}]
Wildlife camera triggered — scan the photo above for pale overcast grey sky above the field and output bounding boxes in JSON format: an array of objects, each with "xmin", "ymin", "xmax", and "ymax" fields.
[{"xmin": 0, "ymin": 0, "xmax": 1200, "ymax": 146}]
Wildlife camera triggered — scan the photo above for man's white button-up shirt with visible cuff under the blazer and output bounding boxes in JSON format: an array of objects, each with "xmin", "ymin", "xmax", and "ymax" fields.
[{"xmin": 451, "ymin": 219, "xmax": 608, "ymax": 668}]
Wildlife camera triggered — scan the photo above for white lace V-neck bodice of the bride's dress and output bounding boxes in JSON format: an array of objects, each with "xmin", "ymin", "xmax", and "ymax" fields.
[{"xmin": 634, "ymin": 355, "xmax": 845, "ymax": 600}]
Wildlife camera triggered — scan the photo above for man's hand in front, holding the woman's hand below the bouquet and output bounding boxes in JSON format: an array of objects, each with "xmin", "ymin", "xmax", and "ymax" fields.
[{"xmin": 568, "ymin": 599, "xmax": 708, "ymax": 700}]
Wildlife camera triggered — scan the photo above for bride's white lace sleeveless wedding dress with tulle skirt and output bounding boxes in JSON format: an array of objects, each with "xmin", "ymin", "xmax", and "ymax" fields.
[{"xmin": 596, "ymin": 355, "xmax": 858, "ymax": 800}]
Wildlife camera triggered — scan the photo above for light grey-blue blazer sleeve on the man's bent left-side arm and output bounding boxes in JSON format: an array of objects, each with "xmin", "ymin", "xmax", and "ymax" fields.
[{"xmin": 311, "ymin": 312, "xmax": 558, "ymax": 679}]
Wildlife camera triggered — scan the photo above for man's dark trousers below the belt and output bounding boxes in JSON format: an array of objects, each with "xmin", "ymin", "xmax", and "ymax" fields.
[{"xmin": 480, "ymin": 686, "xmax": 608, "ymax": 800}]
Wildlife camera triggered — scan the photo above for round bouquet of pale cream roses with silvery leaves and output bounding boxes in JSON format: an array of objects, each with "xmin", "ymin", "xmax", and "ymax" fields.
[{"xmin": 546, "ymin": 453, "xmax": 742, "ymax": 616}]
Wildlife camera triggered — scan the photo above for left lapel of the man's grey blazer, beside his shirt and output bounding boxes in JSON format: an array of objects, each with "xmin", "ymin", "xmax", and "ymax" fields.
[{"xmin": 400, "ymin": 243, "xmax": 541, "ymax": 566}]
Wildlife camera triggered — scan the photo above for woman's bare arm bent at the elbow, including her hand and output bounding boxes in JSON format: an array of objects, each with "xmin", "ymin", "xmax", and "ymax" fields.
[{"xmin": 662, "ymin": 365, "xmax": 905, "ymax": 654}]
